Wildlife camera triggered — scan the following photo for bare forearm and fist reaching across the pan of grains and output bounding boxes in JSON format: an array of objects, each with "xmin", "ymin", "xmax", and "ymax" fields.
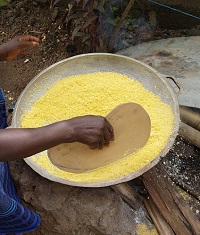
[{"xmin": 0, "ymin": 115, "xmax": 114, "ymax": 161}]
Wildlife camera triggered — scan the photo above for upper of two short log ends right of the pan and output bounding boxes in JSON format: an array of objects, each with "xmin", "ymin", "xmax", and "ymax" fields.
[{"xmin": 179, "ymin": 105, "xmax": 200, "ymax": 131}]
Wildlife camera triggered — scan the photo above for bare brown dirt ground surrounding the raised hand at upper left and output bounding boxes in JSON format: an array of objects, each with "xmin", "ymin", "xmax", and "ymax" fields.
[{"xmin": 0, "ymin": 1, "xmax": 68, "ymax": 124}]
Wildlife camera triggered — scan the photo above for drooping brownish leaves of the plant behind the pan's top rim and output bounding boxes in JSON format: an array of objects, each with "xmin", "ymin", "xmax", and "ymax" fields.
[{"xmin": 64, "ymin": 0, "xmax": 108, "ymax": 51}]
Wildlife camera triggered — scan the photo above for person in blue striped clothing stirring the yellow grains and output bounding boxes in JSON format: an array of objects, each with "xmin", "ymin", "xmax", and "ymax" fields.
[{"xmin": 0, "ymin": 35, "xmax": 114, "ymax": 235}]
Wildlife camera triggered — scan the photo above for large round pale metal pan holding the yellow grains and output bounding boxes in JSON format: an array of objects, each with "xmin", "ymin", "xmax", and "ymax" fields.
[{"xmin": 12, "ymin": 53, "xmax": 179, "ymax": 187}]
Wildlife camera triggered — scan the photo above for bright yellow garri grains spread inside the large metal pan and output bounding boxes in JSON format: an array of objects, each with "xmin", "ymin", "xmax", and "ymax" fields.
[{"xmin": 21, "ymin": 72, "xmax": 174, "ymax": 183}]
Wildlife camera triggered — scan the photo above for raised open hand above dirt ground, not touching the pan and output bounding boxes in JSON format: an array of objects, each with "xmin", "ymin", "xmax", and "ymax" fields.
[{"xmin": 0, "ymin": 35, "xmax": 39, "ymax": 60}]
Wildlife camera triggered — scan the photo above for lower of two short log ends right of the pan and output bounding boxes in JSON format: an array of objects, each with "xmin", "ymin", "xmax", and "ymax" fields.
[{"xmin": 179, "ymin": 122, "xmax": 200, "ymax": 148}]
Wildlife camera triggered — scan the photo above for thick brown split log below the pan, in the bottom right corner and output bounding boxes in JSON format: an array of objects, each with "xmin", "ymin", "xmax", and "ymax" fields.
[{"xmin": 143, "ymin": 164, "xmax": 200, "ymax": 235}]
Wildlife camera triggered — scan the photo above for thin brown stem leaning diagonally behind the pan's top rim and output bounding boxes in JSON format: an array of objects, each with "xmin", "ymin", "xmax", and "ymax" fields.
[{"xmin": 108, "ymin": 0, "xmax": 135, "ymax": 52}]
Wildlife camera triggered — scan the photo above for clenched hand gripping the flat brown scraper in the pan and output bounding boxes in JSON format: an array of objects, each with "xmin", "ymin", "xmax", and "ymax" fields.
[{"xmin": 68, "ymin": 115, "xmax": 114, "ymax": 149}]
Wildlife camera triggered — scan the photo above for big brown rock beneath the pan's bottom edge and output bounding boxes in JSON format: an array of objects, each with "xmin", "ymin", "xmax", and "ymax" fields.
[{"xmin": 7, "ymin": 160, "xmax": 152, "ymax": 235}]
